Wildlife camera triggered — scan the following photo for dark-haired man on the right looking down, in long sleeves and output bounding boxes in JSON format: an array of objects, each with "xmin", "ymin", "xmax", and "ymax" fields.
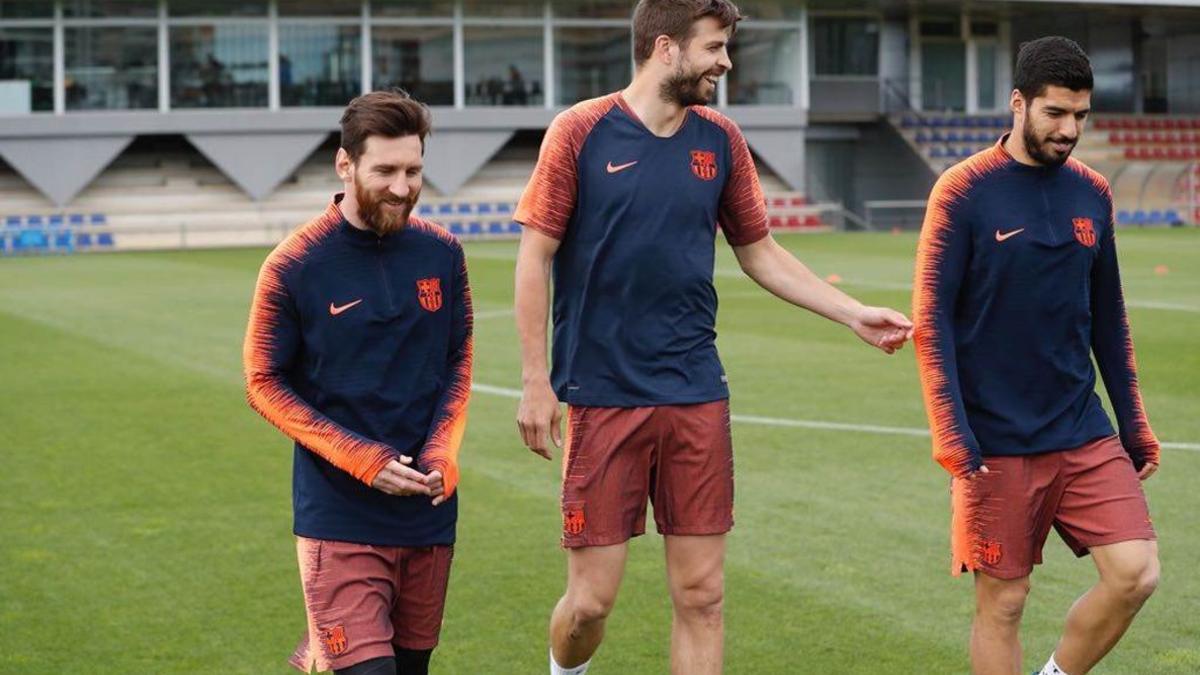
[{"xmin": 913, "ymin": 37, "xmax": 1159, "ymax": 675}]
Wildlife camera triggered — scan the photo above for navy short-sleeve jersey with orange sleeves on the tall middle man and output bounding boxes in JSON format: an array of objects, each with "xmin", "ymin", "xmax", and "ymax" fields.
[{"xmin": 515, "ymin": 94, "xmax": 768, "ymax": 407}]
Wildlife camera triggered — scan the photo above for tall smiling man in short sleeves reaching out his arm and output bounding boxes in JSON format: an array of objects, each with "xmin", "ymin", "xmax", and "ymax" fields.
[{"xmin": 515, "ymin": 0, "xmax": 911, "ymax": 675}]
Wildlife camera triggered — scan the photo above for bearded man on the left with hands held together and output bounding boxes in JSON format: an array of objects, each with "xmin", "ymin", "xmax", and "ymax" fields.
[{"xmin": 245, "ymin": 91, "xmax": 472, "ymax": 675}]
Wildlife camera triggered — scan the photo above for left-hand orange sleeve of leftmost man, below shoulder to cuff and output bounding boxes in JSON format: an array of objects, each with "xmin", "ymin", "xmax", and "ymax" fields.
[{"xmin": 242, "ymin": 241, "xmax": 397, "ymax": 485}]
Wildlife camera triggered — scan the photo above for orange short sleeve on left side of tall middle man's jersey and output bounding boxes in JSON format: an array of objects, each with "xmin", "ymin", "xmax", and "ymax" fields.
[{"xmin": 512, "ymin": 94, "xmax": 619, "ymax": 239}]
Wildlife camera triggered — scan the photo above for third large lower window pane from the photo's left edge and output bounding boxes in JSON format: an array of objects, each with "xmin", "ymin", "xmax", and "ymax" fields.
[{"xmin": 170, "ymin": 24, "xmax": 269, "ymax": 108}]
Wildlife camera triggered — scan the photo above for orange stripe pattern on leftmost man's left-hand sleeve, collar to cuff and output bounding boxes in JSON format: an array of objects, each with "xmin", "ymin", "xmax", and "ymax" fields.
[{"xmin": 242, "ymin": 199, "xmax": 395, "ymax": 485}]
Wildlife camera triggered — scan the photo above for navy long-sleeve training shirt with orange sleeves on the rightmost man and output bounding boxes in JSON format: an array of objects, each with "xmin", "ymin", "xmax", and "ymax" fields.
[{"xmin": 913, "ymin": 137, "xmax": 1159, "ymax": 476}]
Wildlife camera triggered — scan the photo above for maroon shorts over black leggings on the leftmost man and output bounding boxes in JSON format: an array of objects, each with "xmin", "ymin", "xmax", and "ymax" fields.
[{"xmin": 288, "ymin": 537, "xmax": 454, "ymax": 673}]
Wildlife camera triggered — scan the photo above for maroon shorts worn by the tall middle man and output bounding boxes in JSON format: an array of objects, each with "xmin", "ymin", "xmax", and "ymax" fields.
[{"xmin": 563, "ymin": 400, "xmax": 733, "ymax": 549}]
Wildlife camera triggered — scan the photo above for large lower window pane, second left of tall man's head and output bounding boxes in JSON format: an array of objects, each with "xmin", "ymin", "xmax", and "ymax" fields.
[{"xmin": 463, "ymin": 26, "xmax": 546, "ymax": 106}]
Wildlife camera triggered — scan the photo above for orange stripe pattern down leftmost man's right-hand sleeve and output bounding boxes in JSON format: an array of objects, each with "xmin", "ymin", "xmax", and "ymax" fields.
[{"xmin": 408, "ymin": 221, "xmax": 475, "ymax": 498}]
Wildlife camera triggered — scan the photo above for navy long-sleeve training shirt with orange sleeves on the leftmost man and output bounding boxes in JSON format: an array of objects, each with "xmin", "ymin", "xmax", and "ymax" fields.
[{"xmin": 244, "ymin": 196, "xmax": 473, "ymax": 546}]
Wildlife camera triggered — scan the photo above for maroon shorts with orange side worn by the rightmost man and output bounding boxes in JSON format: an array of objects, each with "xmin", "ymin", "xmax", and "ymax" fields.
[{"xmin": 950, "ymin": 436, "xmax": 1154, "ymax": 579}]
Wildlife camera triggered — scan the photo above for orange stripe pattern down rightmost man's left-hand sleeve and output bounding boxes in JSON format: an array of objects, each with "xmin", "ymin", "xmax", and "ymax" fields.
[{"xmin": 912, "ymin": 145, "xmax": 1006, "ymax": 476}]
